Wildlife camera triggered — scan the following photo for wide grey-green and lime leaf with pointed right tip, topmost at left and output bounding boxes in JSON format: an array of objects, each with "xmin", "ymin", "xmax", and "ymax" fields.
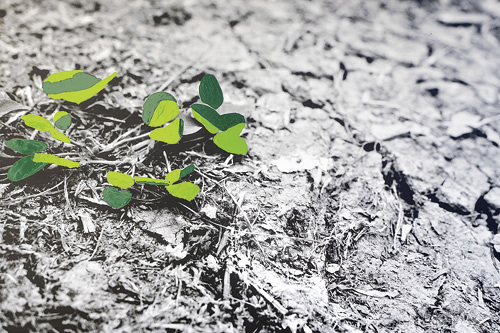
[{"xmin": 42, "ymin": 70, "xmax": 117, "ymax": 104}]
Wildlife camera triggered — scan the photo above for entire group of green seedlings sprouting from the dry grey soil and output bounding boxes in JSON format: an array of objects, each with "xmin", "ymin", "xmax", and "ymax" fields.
[{"xmin": 5, "ymin": 70, "xmax": 248, "ymax": 208}]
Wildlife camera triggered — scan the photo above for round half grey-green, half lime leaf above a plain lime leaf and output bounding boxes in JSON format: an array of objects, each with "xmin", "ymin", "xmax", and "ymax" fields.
[{"xmin": 142, "ymin": 91, "xmax": 179, "ymax": 127}]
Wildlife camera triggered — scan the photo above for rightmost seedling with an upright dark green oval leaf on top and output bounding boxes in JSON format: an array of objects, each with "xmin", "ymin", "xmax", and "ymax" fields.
[{"xmin": 191, "ymin": 74, "xmax": 248, "ymax": 155}]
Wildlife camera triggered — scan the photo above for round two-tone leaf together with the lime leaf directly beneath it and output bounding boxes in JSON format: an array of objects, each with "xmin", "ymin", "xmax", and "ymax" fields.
[{"xmin": 142, "ymin": 91, "xmax": 184, "ymax": 144}]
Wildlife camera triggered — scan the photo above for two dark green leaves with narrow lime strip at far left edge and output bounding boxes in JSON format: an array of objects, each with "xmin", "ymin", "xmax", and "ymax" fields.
[{"xmin": 5, "ymin": 139, "xmax": 80, "ymax": 182}]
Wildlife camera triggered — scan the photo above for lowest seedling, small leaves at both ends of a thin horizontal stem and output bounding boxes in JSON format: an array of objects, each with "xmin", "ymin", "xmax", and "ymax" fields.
[{"xmin": 102, "ymin": 164, "xmax": 200, "ymax": 209}]
